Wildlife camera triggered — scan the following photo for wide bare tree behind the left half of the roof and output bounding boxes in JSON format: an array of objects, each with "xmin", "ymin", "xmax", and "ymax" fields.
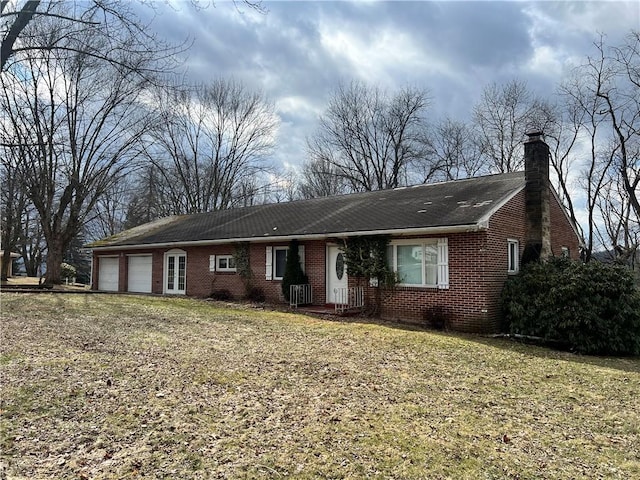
[{"xmin": 149, "ymin": 79, "xmax": 277, "ymax": 213}]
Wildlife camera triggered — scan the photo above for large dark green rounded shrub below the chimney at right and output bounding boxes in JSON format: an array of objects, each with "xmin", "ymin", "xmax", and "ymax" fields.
[{"xmin": 502, "ymin": 259, "xmax": 640, "ymax": 355}]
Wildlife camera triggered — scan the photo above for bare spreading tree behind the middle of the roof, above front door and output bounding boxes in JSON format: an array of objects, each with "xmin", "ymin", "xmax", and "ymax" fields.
[{"xmin": 307, "ymin": 82, "xmax": 429, "ymax": 191}]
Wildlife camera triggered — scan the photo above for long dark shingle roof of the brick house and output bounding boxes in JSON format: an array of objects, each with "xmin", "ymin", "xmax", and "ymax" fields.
[{"xmin": 88, "ymin": 172, "xmax": 525, "ymax": 248}]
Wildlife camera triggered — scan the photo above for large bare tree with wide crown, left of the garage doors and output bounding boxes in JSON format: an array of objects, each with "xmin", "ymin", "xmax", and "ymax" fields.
[{"xmin": 2, "ymin": 4, "xmax": 164, "ymax": 284}]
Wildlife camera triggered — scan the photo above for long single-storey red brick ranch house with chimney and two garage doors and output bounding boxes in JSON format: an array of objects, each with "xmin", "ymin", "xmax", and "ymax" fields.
[{"xmin": 89, "ymin": 133, "xmax": 580, "ymax": 332}]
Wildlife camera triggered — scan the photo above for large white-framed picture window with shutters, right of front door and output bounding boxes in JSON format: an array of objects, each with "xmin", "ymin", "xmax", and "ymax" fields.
[{"xmin": 387, "ymin": 238, "xmax": 449, "ymax": 288}]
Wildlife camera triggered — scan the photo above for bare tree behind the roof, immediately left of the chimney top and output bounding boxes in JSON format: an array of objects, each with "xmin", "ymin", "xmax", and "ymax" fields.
[{"xmin": 473, "ymin": 80, "xmax": 547, "ymax": 173}]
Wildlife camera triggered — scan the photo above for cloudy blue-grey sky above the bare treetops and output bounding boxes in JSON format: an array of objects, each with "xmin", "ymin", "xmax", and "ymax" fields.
[{"xmin": 145, "ymin": 0, "xmax": 640, "ymax": 171}]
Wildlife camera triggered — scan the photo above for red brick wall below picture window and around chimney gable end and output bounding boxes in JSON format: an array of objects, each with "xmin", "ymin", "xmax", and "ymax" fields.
[{"xmin": 376, "ymin": 191, "xmax": 579, "ymax": 332}]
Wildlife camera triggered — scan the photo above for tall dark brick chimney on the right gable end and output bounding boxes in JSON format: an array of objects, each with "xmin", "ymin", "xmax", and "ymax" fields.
[{"xmin": 522, "ymin": 132, "xmax": 551, "ymax": 264}]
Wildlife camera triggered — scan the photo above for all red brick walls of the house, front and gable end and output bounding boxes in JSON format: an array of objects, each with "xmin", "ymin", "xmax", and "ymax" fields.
[{"xmin": 93, "ymin": 186, "xmax": 579, "ymax": 332}]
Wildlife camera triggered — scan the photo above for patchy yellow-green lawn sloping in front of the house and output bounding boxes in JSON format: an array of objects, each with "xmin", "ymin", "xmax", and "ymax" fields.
[{"xmin": 0, "ymin": 293, "xmax": 640, "ymax": 479}]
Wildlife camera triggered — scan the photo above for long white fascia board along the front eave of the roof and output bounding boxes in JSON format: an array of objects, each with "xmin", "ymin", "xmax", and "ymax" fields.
[{"xmin": 87, "ymin": 222, "xmax": 487, "ymax": 253}]
